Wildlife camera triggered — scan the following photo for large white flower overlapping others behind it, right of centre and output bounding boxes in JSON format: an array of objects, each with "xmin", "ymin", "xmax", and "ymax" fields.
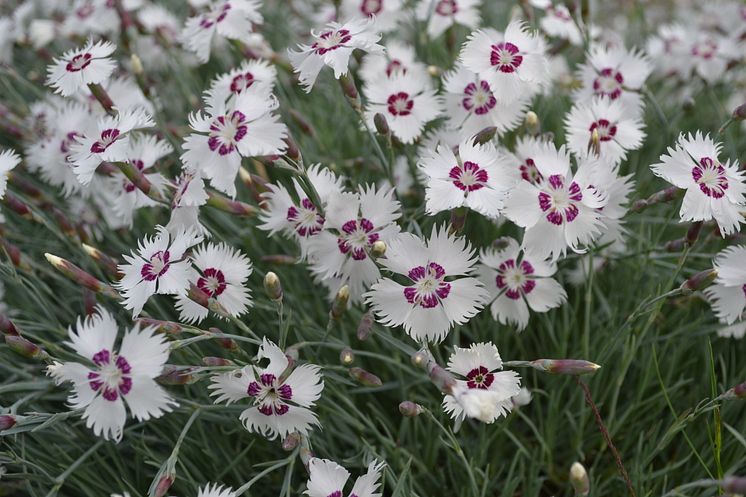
[{"xmin": 503, "ymin": 143, "xmax": 607, "ymax": 260}]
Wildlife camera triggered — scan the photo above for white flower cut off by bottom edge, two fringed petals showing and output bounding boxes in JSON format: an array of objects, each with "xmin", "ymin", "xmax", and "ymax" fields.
[{"xmin": 303, "ymin": 457, "xmax": 385, "ymax": 497}]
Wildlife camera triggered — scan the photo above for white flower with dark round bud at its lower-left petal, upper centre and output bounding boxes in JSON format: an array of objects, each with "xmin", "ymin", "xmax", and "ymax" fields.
[{"xmin": 363, "ymin": 71, "xmax": 441, "ymax": 143}]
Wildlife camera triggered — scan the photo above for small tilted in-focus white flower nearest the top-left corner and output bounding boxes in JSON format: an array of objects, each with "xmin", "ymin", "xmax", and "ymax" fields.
[{"xmin": 47, "ymin": 39, "xmax": 116, "ymax": 97}]
